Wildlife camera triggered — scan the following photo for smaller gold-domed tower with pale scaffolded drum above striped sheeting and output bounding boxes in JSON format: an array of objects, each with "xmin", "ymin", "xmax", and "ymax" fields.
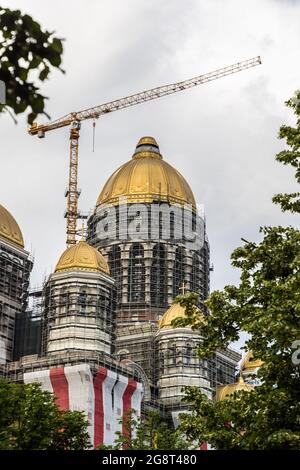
[{"xmin": 42, "ymin": 240, "xmax": 115, "ymax": 355}]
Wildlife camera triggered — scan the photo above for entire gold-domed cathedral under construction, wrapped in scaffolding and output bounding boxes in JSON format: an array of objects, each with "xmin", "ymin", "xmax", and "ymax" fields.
[{"xmin": 0, "ymin": 137, "xmax": 241, "ymax": 447}]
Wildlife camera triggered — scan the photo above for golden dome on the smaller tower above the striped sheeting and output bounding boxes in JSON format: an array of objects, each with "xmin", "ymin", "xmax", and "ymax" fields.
[{"xmin": 55, "ymin": 240, "xmax": 109, "ymax": 274}]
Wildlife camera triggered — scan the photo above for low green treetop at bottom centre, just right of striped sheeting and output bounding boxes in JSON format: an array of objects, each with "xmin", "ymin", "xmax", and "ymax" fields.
[{"xmin": 100, "ymin": 410, "xmax": 193, "ymax": 450}]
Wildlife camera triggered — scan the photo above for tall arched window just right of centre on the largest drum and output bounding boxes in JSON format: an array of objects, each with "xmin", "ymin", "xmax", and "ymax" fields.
[{"xmin": 151, "ymin": 244, "xmax": 168, "ymax": 307}]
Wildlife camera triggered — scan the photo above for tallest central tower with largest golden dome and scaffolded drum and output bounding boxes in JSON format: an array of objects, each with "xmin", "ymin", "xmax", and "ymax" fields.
[{"xmin": 88, "ymin": 137, "xmax": 209, "ymax": 327}]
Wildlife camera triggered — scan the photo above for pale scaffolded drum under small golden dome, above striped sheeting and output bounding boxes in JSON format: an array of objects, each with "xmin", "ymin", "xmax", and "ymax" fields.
[{"xmin": 36, "ymin": 271, "xmax": 116, "ymax": 356}]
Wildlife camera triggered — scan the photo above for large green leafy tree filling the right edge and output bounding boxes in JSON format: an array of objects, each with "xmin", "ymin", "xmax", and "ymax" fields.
[{"xmin": 175, "ymin": 95, "xmax": 300, "ymax": 449}]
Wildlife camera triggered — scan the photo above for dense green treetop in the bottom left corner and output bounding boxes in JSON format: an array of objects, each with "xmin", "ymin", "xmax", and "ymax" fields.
[{"xmin": 0, "ymin": 381, "xmax": 90, "ymax": 450}]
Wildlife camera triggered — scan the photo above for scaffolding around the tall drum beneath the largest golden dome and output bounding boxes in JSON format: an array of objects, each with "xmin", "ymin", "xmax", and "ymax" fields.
[{"xmin": 88, "ymin": 203, "xmax": 209, "ymax": 326}]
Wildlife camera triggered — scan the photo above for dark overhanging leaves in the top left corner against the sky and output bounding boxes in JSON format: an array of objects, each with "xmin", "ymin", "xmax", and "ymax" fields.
[{"xmin": 0, "ymin": 6, "xmax": 63, "ymax": 123}]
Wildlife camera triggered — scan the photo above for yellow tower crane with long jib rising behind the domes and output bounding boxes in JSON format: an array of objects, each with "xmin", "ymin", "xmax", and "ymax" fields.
[{"xmin": 28, "ymin": 56, "xmax": 261, "ymax": 246}]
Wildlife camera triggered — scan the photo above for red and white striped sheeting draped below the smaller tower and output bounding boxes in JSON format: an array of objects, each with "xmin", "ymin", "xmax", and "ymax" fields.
[{"xmin": 24, "ymin": 364, "xmax": 143, "ymax": 447}]
